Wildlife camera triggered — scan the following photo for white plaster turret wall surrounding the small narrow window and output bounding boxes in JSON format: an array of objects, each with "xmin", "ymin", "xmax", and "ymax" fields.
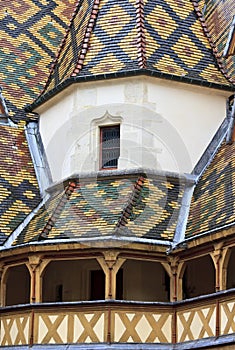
[{"xmin": 37, "ymin": 77, "xmax": 229, "ymax": 181}]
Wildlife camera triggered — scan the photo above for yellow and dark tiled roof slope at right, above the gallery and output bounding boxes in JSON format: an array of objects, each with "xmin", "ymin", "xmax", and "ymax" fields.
[{"xmin": 186, "ymin": 143, "xmax": 235, "ymax": 237}]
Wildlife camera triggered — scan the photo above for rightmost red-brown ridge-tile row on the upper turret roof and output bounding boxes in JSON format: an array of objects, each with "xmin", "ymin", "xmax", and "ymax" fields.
[{"xmin": 192, "ymin": 0, "xmax": 234, "ymax": 84}]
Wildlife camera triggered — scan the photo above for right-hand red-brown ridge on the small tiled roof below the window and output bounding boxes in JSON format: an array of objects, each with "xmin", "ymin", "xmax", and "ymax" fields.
[{"xmin": 116, "ymin": 176, "xmax": 146, "ymax": 228}]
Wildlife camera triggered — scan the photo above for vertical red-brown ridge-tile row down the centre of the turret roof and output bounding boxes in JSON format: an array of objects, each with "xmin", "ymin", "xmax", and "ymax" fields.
[{"xmin": 136, "ymin": 0, "xmax": 147, "ymax": 68}]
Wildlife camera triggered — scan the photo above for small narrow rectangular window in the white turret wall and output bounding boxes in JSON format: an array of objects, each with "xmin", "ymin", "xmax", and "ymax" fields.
[{"xmin": 100, "ymin": 125, "xmax": 120, "ymax": 169}]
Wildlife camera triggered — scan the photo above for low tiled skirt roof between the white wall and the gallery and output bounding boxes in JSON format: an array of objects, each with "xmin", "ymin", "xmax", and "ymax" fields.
[{"xmin": 14, "ymin": 175, "xmax": 185, "ymax": 245}]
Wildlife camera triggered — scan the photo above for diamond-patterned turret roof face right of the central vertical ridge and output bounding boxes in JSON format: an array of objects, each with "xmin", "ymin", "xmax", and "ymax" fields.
[{"xmin": 145, "ymin": 0, "xmax": 227, "ymax": 85}]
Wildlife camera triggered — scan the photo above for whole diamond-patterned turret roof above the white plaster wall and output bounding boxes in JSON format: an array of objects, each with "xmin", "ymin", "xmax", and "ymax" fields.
[{"xmin": 31, "ymin": 0, "xmax": 235, "ymax": 108}]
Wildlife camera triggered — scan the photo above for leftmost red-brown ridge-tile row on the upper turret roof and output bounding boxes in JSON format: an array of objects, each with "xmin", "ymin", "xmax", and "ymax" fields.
[{"xmin": 37, "ymin": 0, "xmax": 81, "ymax": 99}]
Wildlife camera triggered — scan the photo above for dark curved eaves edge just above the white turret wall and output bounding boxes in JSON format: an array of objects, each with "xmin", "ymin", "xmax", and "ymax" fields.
[{"xmin": 25, "ymin": 69, "xmax": 235, "ymax": 112}]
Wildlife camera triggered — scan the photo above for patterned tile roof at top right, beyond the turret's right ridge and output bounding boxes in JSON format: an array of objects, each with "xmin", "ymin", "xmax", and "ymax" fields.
[{"xmin": 199, "ymin": 0, "xmax": 235, "ymax": 83}]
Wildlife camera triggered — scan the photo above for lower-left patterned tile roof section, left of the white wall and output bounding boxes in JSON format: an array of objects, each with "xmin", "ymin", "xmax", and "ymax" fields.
[{"xmin": 0, "ymin": 124, "xmax": 40, "ymax": 244}]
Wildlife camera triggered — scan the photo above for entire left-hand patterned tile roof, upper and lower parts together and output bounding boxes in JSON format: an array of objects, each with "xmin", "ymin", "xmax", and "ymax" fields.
[{"xmin": 0, "ymin": 0, "xmax": 74, "ymax": 244}]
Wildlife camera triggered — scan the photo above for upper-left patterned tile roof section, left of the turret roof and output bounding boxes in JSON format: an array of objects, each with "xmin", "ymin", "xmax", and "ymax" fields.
[{"xmin": 0, "ymin": 0, "xmax": 74, "ymax": 121}]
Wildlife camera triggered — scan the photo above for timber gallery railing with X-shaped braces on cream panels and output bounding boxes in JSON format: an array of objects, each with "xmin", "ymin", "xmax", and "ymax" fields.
[{"xmin": 0, "ymin": 289, "xmax": 235, "ymax": 346}]
